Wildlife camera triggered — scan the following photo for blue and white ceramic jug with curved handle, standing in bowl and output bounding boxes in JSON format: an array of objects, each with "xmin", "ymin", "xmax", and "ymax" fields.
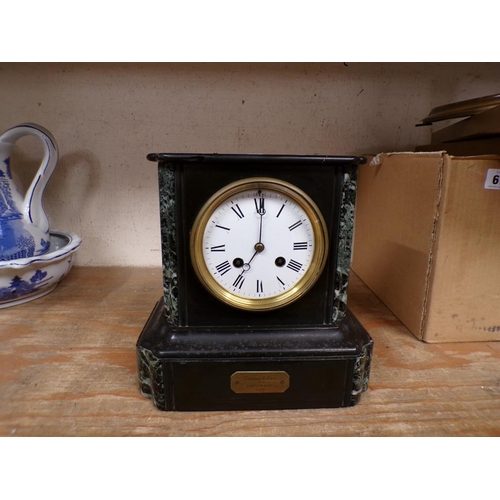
[{"xmin": 0, "ymin": 123, "xmax": 59, "ymax": 261}]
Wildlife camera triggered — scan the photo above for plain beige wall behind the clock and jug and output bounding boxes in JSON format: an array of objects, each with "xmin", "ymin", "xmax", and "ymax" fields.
[{"xmin": 0, "ymin": 63, "xmax": 500, "ymax": 266}]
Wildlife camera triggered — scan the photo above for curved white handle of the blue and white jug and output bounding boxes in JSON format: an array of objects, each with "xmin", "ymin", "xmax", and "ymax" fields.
[{"xmin": 2, "ymin": 123, "xmax": 59, "ymax": 232}]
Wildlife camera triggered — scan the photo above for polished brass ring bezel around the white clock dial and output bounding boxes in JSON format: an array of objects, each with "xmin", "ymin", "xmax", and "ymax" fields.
[{"xmin": 190, "ymin": 177, "xmax": 329, "ymax": 311}]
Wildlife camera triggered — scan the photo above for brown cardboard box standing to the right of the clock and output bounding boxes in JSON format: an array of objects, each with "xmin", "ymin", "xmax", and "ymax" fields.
[{"xmin": 352, "ymin": 152, "xmax": 500, "ymax": 342}]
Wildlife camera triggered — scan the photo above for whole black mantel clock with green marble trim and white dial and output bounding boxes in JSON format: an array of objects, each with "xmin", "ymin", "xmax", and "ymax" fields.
[{"xmin": 137, "ymin": 153, "xmax": 373, "ymax": 411}]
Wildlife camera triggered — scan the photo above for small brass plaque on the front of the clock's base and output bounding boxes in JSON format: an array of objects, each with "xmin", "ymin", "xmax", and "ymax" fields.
[{"xmin": 231, "ymin": 371, "xmax": 290, "ymax": 394}]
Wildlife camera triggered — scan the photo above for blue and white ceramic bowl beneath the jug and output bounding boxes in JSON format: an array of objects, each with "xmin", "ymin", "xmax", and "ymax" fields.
[{"xmin": 0, "ymin": 231, "xmax": 82, "ymax": 308}]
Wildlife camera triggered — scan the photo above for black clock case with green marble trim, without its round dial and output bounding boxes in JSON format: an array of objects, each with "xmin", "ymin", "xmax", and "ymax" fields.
[{"xmin": 137, "ymin": 153, "xmax": 373, "ymax": 411}]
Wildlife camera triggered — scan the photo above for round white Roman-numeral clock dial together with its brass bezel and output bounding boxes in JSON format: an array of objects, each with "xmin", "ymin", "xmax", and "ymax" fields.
[{"xmin": 191, "ymin": 178, "xmax": 328, "ymax": 311}]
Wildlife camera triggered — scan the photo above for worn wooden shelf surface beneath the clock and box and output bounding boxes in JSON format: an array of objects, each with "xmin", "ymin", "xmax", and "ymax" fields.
[{"xmin": 0, "ymin": 267, "xmax": 500, "ymax": 436}]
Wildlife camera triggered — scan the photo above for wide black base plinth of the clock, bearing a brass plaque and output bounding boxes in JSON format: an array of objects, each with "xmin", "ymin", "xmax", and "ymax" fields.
[{"xmin": 137, "ymin": 301, "xmax": 373, "ymax": 411}]
